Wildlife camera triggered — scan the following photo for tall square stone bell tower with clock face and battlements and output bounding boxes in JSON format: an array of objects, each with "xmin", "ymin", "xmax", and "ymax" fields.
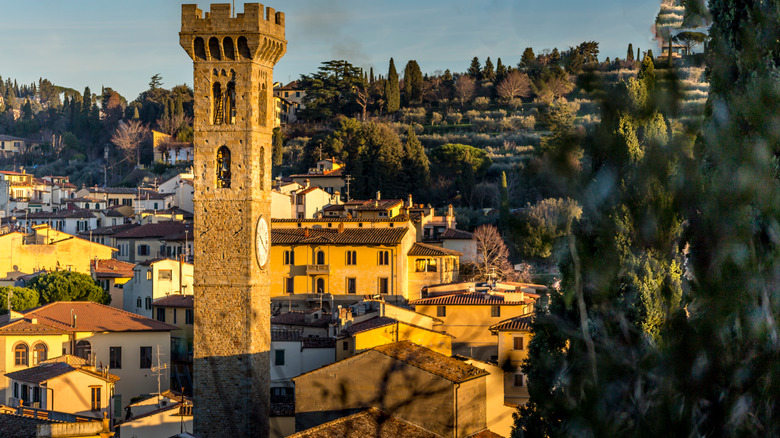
[{"xmin": 179, "ymin": 3, "xmax": 287, "ymax": 438}]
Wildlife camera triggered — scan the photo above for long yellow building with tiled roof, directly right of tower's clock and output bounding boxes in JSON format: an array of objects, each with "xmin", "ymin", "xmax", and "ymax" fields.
[{"xmin": 271, "ymin": 216, "xmax": 460, "ymax": 300}]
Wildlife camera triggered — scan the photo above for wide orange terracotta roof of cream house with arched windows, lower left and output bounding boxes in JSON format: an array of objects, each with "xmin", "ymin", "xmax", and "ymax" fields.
[{"xmin": 0, "ymin": 301, "xmax": 178, "ymax": 334}]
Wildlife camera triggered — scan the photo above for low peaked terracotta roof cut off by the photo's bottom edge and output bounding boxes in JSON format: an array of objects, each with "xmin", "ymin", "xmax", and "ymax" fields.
[{"xmin": 289, "ymin": 408, "xmax": 441, "ymax": 438}]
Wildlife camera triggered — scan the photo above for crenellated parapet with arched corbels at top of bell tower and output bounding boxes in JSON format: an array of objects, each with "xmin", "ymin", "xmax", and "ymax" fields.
[{"xmin": 179, "ymin": 3, "xmax": 287, "ymax": 66}]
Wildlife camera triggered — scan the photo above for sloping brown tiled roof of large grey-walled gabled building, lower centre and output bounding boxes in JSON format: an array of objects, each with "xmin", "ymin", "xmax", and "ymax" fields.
[{"xmin": 369, "ymin": 341, "xmax": 490, "ymax": 383}]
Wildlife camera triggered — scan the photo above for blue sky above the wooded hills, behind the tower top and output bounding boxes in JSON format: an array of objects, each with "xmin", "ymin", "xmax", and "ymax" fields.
[{"xmin": 0, "ymin": 0, "xmax": 660, "ymax": 101}]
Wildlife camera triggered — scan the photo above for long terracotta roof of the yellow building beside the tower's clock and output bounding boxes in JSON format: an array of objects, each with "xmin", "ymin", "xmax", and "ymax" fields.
[{"xmin": 271, "ymin": 227, "xmax": 408, "ymax": 245}]
